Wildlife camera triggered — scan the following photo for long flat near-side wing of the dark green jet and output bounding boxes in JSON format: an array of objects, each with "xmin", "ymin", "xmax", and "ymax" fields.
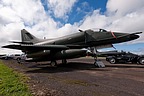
[{"xmin": 2, "ymin": 44, "xmax": 69, "ymax": 50}]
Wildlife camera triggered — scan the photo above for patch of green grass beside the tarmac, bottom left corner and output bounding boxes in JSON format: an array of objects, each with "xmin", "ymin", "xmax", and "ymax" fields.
[{"xmin": 0, "ymin": 61, "xmax": 32, "ymax": 96}]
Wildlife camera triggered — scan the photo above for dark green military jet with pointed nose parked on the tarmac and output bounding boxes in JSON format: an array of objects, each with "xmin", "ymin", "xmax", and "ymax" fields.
[{"xmin": 3, "ymin": 29, "xmax": 141, "ymax": 66}]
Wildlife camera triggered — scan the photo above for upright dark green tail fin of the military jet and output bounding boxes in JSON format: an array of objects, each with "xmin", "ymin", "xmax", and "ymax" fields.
[{"xmin": 21, "ymin": 29, "xmax": 40, "ymax": 43}]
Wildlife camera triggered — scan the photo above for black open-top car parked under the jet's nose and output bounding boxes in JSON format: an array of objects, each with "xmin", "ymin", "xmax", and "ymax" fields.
[{"xmin": 106, "ymin": 52, "xmax": 144, "ymax": 65}]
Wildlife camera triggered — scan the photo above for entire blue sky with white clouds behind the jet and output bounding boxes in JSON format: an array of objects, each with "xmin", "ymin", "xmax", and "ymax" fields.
[{"xmin": 0, "ymin": 0, "xmax": 144, "ymax": 54}]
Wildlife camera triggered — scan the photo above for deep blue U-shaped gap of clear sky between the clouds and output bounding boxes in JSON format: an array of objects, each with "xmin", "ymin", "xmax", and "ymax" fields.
[{"xmin": 41, "ymin": 0, "xmax": 108, "ymax": 24}]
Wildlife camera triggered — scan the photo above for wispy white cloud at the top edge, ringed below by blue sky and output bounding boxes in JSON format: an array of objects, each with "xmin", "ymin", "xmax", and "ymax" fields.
[{"xmin": 48, "ymin": 0, "xmax": 77, "ymax": 19}]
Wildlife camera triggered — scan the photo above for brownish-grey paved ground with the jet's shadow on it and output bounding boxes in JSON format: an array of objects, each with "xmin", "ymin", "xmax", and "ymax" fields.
[{"xmin": 3, "ymin": 58, "xmax": 144, "ymax": 96}]
